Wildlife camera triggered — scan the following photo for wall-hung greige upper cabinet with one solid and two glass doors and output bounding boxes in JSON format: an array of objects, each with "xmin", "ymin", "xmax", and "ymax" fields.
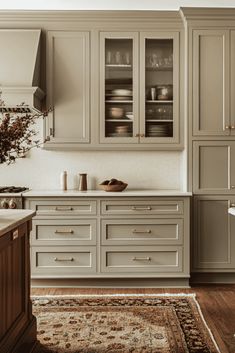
[{"xmin": 42, "ymin": 11, "xmax": 185, "ymax": 151}]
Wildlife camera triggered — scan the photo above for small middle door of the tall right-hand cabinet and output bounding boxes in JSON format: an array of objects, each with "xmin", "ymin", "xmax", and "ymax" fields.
[{"xmin": 193, "ymin": 141, "xmax": 235, "ymax": 194}]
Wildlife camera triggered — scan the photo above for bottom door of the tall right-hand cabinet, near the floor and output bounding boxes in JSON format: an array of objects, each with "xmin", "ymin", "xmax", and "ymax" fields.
[{"xmin": 192, "ymin": 195, "xmax": 235, "ymax": 272}]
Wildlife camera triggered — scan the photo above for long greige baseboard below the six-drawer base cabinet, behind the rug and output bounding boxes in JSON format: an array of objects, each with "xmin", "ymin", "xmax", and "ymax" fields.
[{"xmin": 31, "ymin": 278, "xmax": 190, "ymax": 288}]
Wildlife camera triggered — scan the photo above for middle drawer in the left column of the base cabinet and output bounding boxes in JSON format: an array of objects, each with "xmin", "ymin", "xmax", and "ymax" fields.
[{"xmin": 31, "ymin": 219, "xmax": 96, "ymax": 245}]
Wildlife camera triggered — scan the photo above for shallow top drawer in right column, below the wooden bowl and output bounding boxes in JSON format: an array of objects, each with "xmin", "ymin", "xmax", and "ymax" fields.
[{"xmin": 101, "ymin": 200, "xmax": 183, "ymax": 216}]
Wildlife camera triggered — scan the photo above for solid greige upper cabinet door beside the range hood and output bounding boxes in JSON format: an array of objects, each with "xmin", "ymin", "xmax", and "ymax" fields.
[{"xmin": 47, "ymin": 31, "xmax": 90, "ymax": 144}]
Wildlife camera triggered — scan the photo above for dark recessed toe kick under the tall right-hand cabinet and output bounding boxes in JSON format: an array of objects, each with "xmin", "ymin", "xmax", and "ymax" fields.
[{"xmin": 190, "ymin": 272, "xmax": 235, "ymax": 284}]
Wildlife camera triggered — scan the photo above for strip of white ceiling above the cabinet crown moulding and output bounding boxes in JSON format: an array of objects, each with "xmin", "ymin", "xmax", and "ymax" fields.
[{"xmin": 0, "ymin": 0, "xmax": 235, "ymax": 10}]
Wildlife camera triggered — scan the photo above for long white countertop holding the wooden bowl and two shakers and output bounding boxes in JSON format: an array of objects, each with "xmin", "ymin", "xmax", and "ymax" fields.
[{"xmin": 23, "ymin": 189, "xmax": 192, "ymax": 198}]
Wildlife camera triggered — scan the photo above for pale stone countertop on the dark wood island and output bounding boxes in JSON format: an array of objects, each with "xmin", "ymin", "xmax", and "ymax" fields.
[{"xmin": 0, "ymin": 209, "xmax": 36, "ymax": 237}]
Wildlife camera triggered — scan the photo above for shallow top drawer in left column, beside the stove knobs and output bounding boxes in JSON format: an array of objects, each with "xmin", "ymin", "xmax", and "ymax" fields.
[{"xmin": 28, "ymin": 199, "xmax": 97, "ymax": 217}]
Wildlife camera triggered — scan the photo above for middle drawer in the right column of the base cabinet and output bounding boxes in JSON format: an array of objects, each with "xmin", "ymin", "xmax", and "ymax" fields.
[{"xmin": 101, "ymin": 218, "xmax": 183, "ymax": 245}]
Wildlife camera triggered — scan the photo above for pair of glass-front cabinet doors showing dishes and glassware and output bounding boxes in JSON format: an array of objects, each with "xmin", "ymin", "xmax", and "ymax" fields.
[{"xmin": 100, "ymin": 32, "xmax": 179, "ymax": 144}]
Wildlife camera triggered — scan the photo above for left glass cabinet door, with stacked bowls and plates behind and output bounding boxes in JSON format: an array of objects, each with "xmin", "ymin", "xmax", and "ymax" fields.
[{"xmin": 100, "ymin": 33, "xmax": 138, "ymax": 143}]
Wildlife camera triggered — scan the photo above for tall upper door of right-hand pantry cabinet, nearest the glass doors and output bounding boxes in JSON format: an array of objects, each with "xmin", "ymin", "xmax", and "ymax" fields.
[{"xmin": 193, "ymin": 30, "xmax": 230, "ymax": 136}]
